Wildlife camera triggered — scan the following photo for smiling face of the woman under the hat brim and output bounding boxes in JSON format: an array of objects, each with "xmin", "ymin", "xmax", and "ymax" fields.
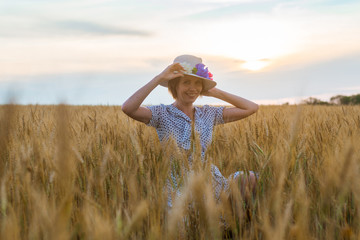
[{"xmin": 176, "ymin": 77, "xmax": 203, "ymax": 104}]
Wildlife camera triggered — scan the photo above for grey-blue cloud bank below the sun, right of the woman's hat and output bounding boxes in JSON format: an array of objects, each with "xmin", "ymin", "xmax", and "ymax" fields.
[{"xmin": 212, "ymin": 52, "xmax": 360, "ymax": 103}]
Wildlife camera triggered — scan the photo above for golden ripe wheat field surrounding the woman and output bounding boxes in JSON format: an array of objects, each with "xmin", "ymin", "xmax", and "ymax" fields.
[{"xmin": 0, "ymin": 104, "xmax": 360, "ymax": 239}]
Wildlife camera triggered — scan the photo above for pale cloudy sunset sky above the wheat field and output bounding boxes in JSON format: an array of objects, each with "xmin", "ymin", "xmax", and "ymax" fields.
[{"xmin": 0, "ymin": 0, "xmax": 360, "ymax": 105}]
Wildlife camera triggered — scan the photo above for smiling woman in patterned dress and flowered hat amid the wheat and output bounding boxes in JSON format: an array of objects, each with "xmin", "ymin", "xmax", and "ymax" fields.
[{"xmin": 122, "ymin": 55, "xmax": 258, "ymax": 207}]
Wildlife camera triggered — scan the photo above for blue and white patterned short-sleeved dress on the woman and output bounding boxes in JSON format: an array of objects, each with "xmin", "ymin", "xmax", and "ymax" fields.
[{"xmin": 147, "ymin": 104, "xmax": 243, "ymax": 207}]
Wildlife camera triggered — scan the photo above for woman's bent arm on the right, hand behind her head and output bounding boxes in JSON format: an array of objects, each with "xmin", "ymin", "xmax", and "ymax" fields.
[{"xmin": 204, "ymin": 88, "xmax": 259, "ymax": 123}]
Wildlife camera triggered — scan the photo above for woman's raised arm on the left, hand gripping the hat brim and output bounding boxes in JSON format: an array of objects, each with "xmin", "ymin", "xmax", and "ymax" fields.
[{"xmin": 121, "ymin": 63, "xmax": 184, "ymax": 123}]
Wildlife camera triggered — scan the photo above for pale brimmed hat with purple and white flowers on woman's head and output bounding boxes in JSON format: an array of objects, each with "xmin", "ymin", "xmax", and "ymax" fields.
[{"xmin": 160, "ymin": 55, "xmax": 216, "ymax": 91}]
